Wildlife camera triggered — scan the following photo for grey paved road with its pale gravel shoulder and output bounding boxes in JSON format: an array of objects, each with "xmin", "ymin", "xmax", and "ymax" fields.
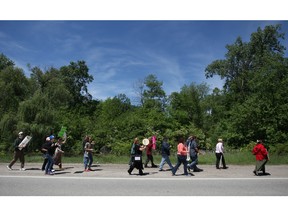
[{"xmin": 0, "ymin": 163, "xmax": 288, "ymax": 196}]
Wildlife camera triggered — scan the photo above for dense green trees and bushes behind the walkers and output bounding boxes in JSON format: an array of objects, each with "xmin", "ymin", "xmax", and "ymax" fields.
[{"xmin": 0, "ymin": 25, "xmax": 288, "ymax": 155}]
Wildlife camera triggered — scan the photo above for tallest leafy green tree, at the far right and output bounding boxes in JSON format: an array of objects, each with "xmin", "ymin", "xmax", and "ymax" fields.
[{"xmin": 205, "ymin": 25, "xmax": 288, "ymax": 146}]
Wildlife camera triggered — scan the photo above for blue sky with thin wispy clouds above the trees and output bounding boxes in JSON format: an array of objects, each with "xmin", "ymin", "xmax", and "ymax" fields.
[{"xmin": 0, "ymin": 20, "xmax": 288, "ymax": 102}]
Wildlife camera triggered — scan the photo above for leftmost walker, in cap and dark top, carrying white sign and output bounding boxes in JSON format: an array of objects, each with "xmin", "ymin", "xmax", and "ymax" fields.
[{"xmin": 7, "ymin": 131, "xmax": 25, "ymax": 171}]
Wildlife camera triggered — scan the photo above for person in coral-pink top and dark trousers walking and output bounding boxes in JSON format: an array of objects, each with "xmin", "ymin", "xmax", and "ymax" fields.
[{"xmin": 172, "ymin": 138, "xmax": 189, "ymax": 176}]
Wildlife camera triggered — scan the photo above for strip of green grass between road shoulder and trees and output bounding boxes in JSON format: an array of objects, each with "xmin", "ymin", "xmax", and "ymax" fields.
[{"xmin": 0, "ymin": 151, "xmax": 288, "ymax": 165}]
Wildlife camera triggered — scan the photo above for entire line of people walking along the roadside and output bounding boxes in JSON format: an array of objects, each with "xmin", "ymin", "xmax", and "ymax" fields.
[{"xmin": 7, "ymin": 132, "xmax": 269, "ymax": 176}]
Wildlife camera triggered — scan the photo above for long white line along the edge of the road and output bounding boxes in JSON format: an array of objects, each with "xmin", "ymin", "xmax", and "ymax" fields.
[{"xmin": 0, "ymin": 175, "xmax": 288, "ymax": 181}]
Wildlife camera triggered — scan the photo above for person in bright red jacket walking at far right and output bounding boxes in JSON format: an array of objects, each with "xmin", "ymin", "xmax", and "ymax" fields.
[{"xmin": 252, "ymin": 140, "xmax": 269, "ymax": 176}]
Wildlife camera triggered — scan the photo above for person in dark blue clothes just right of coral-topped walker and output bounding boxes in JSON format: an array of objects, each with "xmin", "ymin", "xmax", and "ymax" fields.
[{"xmin": 186, "ymin": 136, "xmax": 203, "ymax": 172}]
